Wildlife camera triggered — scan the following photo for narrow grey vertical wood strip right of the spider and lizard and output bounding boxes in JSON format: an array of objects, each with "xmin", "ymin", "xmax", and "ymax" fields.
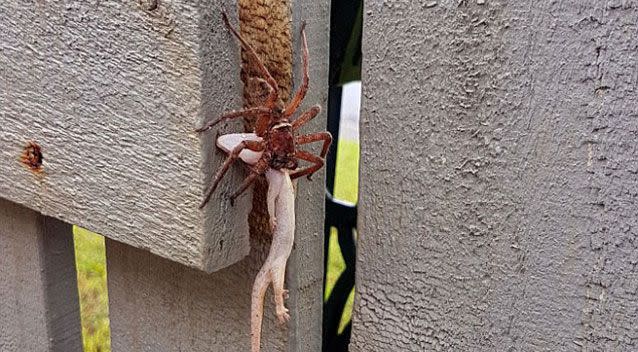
[{"xmin": 286, "ymin": 0, "xmax": 330, "ymax": 352}]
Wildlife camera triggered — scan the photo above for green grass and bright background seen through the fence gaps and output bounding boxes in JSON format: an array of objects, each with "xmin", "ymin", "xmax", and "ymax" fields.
[{"xmin": 73, "ymin": 141, "xmax": 359, "ymax": 352}]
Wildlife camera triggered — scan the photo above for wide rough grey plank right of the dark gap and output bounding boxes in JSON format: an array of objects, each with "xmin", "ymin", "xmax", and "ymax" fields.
[{"xmin": 351, "ymin": 0, "xmax": 638, "ymax": 352}]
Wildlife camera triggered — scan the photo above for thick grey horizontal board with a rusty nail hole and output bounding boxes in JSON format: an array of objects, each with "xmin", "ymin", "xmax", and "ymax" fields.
[{"xmin": 0, "ymin": 0, "xmax": 251, "ymax": 271}]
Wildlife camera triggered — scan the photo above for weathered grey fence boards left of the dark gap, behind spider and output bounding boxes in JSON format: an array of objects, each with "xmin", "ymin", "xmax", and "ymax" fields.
[{"xmin": 0, "ymin": 0, "xmax": 329, "ymax": 352}]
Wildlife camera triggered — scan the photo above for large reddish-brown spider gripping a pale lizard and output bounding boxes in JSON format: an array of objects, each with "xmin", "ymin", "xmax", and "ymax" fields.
[{"xmin": 197, "ymin": 13, "xmax": 332, "ymax": 208}]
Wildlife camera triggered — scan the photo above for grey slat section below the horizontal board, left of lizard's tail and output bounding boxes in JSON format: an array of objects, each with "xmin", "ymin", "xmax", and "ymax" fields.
[{"xmin": 106, "ymin": 239, "xmax": 286, "ymax": 352}]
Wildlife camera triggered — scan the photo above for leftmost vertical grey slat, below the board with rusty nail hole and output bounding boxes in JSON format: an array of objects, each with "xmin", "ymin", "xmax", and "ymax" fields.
[{"xmin": 0, "ymin": 199, "xmax": 82, "ymax": 352}]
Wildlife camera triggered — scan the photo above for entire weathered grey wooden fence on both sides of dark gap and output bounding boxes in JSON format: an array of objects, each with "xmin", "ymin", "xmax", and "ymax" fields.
[{"xmin": 0, "ymin": 0, "xmax": 638, "ymax": 352}]
